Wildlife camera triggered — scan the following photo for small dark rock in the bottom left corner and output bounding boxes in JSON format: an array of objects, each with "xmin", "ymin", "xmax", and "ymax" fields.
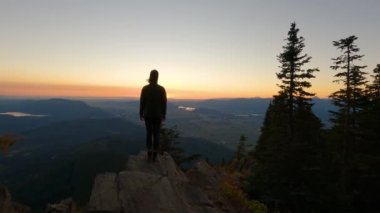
[{"xmin": 0, "ymin": 184, "xmax": 30, "ymax": 213}]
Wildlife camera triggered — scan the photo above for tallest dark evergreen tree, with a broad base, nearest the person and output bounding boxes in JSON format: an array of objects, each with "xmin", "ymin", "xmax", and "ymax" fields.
[{"xmin": 248, "ymin": 23, "xmax": 321, "ymax": 212}]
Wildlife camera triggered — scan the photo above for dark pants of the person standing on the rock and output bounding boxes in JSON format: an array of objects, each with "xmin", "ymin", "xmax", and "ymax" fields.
[{"xmin": 144, "ymin": 118, "xmax": 161, "ymax": 152}]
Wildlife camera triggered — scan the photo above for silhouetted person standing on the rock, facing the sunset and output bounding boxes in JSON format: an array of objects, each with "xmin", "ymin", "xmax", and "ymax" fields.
[{"xmin": 140, "ymin": 70, "xmax": 167, "ymax": 162}]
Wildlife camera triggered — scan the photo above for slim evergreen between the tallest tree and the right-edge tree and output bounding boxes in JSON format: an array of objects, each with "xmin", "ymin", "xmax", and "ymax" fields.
[{"xmin": 330, "ymin": 36, "xmax": 367, "ymax": 198}]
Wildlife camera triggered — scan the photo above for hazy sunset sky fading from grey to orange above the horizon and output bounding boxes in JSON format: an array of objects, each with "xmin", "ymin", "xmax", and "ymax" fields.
[{"xmin": 0, "ymin": 0, "xmax": 380, "ymax": 99}]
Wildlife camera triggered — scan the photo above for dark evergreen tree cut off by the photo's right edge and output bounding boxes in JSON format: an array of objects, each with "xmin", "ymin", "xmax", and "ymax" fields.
[{"xmin": 345, "ymin": 64, "xmax": 380, "ymax": 212}]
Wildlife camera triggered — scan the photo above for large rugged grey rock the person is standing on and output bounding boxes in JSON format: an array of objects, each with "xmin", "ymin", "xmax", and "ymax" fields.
[{"xmin": 87, "ymin": 152, "xmax": 225, "ymax": 213}]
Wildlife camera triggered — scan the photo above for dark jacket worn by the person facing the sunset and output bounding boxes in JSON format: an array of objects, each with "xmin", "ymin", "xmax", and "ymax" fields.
[{"xmin": 140, "ymin": 84, "xmax": 167, "ymax": 119}]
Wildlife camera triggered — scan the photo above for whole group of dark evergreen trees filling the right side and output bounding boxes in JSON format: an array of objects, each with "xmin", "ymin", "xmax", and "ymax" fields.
[{"xmin": 246, "ymin": 23, "xmax": 380, "ymax": 212}]
